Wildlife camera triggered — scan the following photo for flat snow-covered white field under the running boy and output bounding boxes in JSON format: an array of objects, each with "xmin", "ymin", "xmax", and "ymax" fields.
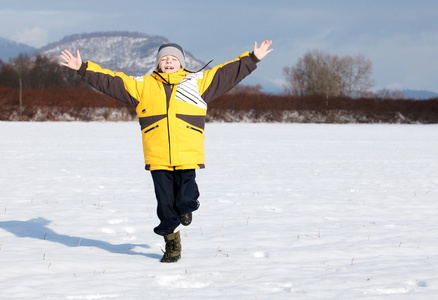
[{"xmin": 0, "ymin": 122, "xmax": 438, "ymax": 300}]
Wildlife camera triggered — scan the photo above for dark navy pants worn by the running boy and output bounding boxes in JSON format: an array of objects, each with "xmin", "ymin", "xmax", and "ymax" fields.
[{"xmin": 151, "ymin": 170, "xmax": 199, "ymax": 236}]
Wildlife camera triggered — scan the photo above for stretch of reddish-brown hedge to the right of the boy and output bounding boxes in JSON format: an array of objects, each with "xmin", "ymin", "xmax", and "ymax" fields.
[{"xmin": 208, "ymin": 94, "xmax": 438, "ymax": 124}]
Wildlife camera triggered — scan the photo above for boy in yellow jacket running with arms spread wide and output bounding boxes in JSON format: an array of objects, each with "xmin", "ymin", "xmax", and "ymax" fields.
[{"xmin": 61, "ymin": 41, "xmax": 273, "ymax": 263}]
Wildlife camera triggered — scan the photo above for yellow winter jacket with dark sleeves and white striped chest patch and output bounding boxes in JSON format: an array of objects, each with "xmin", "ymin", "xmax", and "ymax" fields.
[{"xmin": 78, "ymin": 52, "xmax": 258, "ymax": 170}]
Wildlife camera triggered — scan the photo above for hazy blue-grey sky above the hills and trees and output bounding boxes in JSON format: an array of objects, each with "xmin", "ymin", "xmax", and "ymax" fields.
[{"xmin": 0, "ymin": 0, "xmax": 438, "ymax": 92}]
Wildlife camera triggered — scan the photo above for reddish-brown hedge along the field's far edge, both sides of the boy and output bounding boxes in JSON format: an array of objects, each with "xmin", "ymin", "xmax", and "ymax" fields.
[{"xmin": 0, "ymin": 87, "xmax": 438, "ymax": 124}]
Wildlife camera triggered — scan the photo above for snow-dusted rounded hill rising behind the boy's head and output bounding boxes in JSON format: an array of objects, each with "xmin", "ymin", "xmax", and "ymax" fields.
[{"xmin": 37, "ymin": 32, "xmax": 204, "ymax": 76}]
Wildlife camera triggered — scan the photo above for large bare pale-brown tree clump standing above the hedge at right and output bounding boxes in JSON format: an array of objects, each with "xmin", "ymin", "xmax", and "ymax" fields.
[{"xmin": 283, "ymin": 50, "xmax": 372, "ymax": 96}]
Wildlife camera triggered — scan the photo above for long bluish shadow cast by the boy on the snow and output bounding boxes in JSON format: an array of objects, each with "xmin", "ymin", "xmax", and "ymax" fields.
[{"xmin": 0, "ymin": 218, "xmax": 161, "ymax": 259}]
